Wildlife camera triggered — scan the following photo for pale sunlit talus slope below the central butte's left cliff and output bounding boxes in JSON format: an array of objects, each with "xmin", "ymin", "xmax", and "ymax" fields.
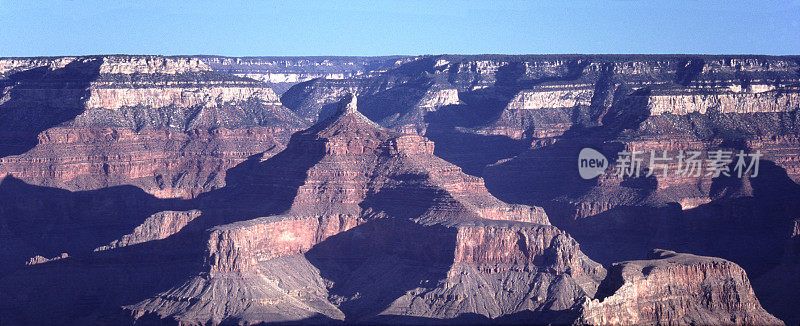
[{"xmin": 126, "ymin": 256, "xmax": 344, "ymax": 325}]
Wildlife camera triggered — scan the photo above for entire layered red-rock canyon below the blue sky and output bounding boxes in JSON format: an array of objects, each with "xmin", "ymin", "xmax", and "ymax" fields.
[{"xmin": 0, "ymin": 55, "xmax": 800, "ymax": 325}]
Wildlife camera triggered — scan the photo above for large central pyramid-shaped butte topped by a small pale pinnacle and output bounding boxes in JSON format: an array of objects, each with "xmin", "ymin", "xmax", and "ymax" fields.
[{"xmin": 127, "ymin": 94, "xmax": 592, "ymax": 323}]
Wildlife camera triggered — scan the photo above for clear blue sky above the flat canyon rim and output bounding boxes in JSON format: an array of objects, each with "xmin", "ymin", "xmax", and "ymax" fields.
[{"xmin": 0, "ymin": 0, "xmax": 800, "ymax": 56}]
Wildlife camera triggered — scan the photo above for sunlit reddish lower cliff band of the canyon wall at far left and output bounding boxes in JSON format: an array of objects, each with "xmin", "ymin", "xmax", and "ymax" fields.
[{"xmin": 0, "ymin": 127, "xmax": 288, "ymax": 198}]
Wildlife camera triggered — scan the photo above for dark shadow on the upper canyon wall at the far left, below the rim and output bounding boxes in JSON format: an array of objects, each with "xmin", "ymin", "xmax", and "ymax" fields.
[{"xmin": 0, "ymin": 58, "xmax": 103, "ymax": 158}]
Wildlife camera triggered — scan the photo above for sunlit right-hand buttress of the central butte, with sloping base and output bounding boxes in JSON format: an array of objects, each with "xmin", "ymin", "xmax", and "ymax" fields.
[{"xmin": 382, "ymin": 221, "xmax": 606, "ymax": 322}]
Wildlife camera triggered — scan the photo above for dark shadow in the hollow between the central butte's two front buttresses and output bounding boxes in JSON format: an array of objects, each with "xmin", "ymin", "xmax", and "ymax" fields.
[{"xmin": 305, "ymin": 219, "xmax": 456, "ymax": 322}]
